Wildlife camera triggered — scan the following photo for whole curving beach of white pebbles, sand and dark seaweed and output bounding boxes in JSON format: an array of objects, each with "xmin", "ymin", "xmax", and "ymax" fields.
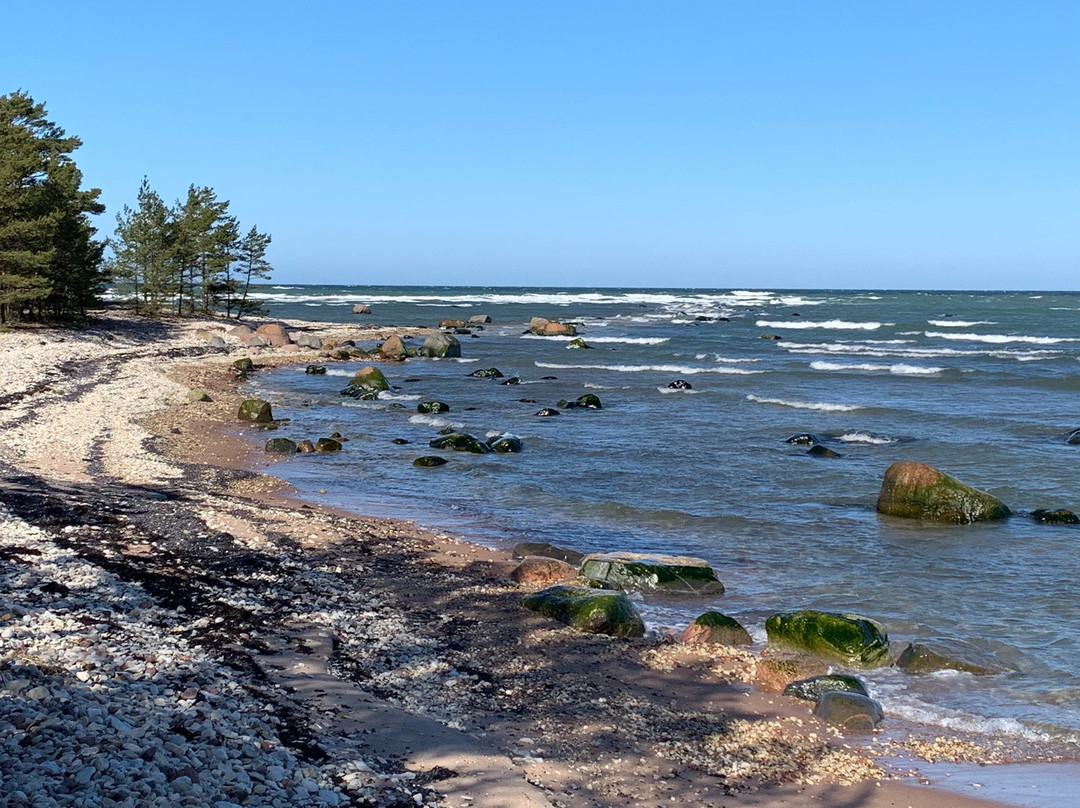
[{"xmin": 0, "ymin": 314, "xmax": 1052, "ymax": 808}]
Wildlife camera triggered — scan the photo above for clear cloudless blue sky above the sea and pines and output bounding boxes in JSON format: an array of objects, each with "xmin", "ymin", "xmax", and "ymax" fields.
[{"xmin": 8, "ymin": 0, "xmax": 1080, "ymax": 289}]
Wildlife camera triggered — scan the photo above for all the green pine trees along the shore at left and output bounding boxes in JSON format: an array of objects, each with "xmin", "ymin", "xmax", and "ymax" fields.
[{"xmin": 0, "ymin": 91, "xmax": 272, "ymax": 323}]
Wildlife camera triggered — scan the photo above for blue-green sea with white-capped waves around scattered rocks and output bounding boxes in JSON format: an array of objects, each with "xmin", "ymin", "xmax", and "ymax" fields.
[{"xmin": 240, "ymin": 286, "xmax": 1080, "ymax": 749}]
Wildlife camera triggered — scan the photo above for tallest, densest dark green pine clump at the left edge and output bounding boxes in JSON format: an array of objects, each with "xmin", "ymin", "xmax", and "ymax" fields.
[{"xmin": 0, "ymin": 91, "xmax": 105, "ymax": 323}]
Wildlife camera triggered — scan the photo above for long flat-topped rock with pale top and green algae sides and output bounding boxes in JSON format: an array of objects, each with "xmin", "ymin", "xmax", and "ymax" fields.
[{"xmin": 581, "ymin": 553, "xmax": 724, "ymax": 595}]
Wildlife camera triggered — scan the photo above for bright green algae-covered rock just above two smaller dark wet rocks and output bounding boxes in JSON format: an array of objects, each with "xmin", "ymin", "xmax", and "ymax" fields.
[{"xmin": 765, "ymin": 609, "xmax": 892, "ymax": 670}]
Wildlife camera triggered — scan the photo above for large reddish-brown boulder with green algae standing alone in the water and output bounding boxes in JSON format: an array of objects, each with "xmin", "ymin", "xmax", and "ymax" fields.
[{"xmin": 877, "ymin": 460, "xmax": 1012, "ymax": 525}]
